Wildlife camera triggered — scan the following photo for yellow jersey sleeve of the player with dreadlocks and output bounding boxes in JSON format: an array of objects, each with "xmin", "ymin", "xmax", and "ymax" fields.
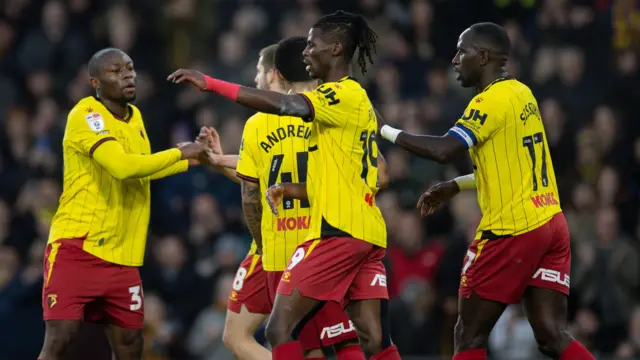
[{"xmin": 300, "ymin": 83, "xmax": 353, "ymax": 126}]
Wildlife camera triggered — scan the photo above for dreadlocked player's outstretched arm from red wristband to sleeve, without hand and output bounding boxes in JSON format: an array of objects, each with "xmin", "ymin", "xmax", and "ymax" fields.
[{"xmin": 205, "ymin": 76, "xmax": 311, "ymax": 118}]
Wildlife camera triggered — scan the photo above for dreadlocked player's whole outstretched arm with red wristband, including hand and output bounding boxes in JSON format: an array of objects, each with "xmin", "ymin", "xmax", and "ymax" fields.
[{"xmin": 167, "ymin": 69, "xmax": 312, "ymax": 119}]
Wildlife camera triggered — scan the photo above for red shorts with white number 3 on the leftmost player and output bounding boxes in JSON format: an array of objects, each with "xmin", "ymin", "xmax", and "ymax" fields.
[{"xmin": 42, "ymin": 239, "xmax": 144, "ymax": 329}]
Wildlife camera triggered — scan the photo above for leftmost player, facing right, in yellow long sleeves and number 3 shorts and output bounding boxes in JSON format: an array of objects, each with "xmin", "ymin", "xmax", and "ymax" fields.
[{"xmin": 39, "ymin": 48, "xmax": 210, "ymax": 360}]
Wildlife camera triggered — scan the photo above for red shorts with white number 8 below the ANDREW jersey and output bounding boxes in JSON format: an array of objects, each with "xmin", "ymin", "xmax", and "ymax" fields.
[{"xmin": 227, "ymin": 254, "xmax": 271, "ymax": 314}]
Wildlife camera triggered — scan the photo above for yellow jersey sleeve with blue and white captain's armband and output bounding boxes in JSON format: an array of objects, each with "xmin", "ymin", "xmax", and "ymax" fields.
[{"xmin": 449, "ymin": 94, "xmax": 505, "ymax": 149}]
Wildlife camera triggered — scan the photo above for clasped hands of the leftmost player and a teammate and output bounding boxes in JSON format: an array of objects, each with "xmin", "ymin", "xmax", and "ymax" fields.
[{"xmin": 178, "ymin": 126, "xmax": 224, "ymax": 166}]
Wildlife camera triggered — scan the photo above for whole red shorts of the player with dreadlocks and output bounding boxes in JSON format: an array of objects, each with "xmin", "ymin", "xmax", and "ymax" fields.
[{"xmin": 277, "ymin": 237, "xmax": 389, "ymax": 304}]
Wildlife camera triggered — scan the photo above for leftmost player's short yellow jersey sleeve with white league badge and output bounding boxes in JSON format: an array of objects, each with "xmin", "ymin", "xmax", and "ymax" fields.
[{"xmin": 65, "ymin": 109, "xmax": 116, "ymax": 157}]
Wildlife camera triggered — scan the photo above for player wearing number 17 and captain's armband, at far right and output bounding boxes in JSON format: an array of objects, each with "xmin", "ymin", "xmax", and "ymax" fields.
[{"xmin": 381, "ymin": 23, "xmax": 593, "ymax": 360}]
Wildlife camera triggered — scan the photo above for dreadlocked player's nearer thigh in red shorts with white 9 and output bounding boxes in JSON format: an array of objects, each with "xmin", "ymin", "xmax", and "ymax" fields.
[{"xmin": 277, "ymin": 237, "xmax": 373, "ymax": 302}]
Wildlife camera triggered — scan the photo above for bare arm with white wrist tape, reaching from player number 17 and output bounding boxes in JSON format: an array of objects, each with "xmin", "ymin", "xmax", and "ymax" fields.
[{"xmin": 380, "ymin": 125, "xmax": 464, "ymax": 164}]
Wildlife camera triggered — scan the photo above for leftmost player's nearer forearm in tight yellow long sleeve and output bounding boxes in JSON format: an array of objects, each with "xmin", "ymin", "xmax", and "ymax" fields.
[{"xmin": 93, "ymin": 141, "xmax": 182, "ymax": 180}]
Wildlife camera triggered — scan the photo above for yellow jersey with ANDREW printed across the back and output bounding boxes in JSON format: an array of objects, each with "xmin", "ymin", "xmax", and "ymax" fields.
[{"xmin": 236, "ymin": 113, "xmax": 311, "ymax": 271}]
